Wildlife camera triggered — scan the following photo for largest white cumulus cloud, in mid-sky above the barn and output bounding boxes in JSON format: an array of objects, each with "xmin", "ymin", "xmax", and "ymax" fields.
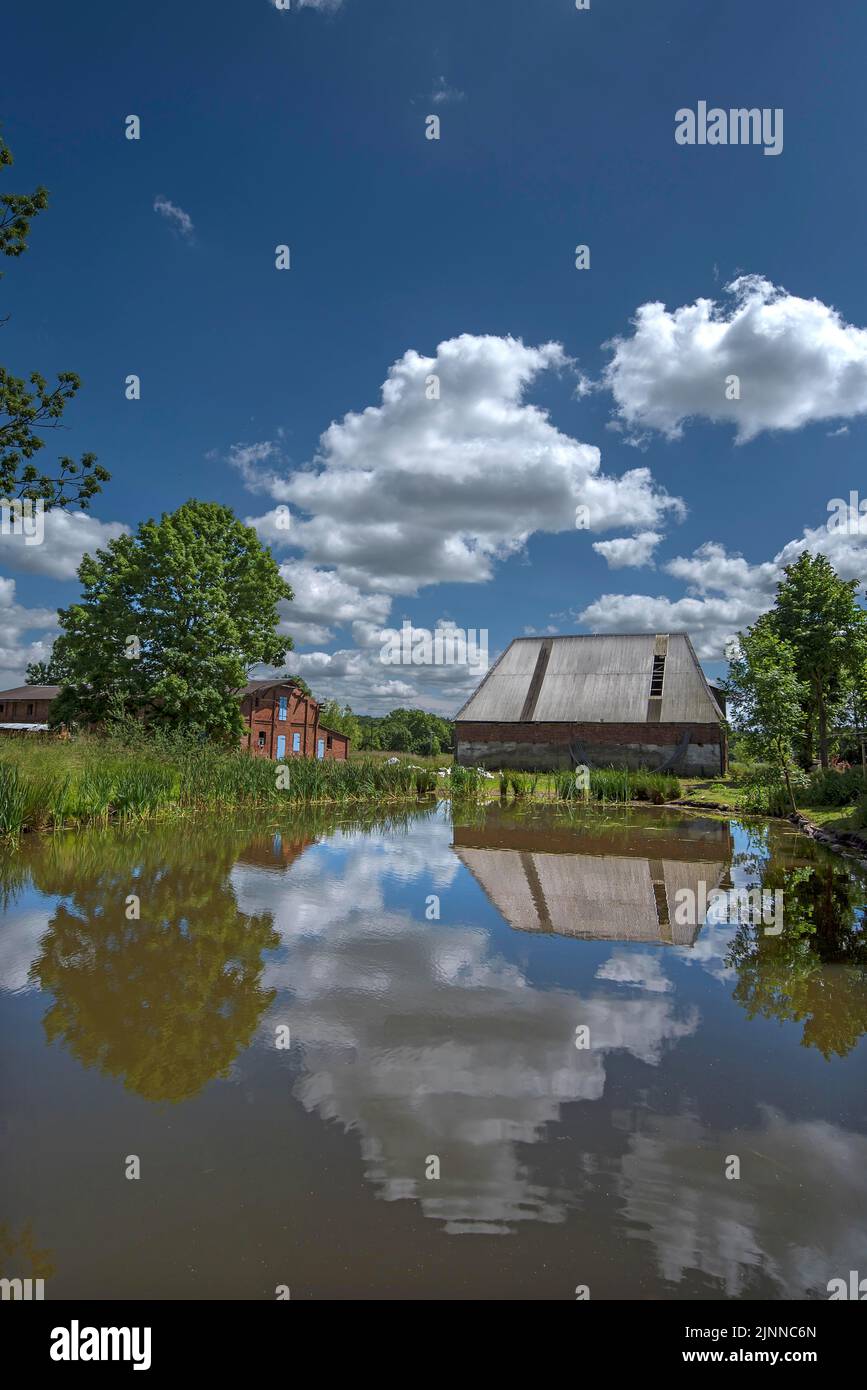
[{"xmin": 245, "ymin": 334, "xmax": 684, "ymax": 595}]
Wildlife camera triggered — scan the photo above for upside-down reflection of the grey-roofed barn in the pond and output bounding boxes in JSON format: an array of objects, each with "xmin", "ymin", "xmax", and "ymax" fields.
[{"xmin": 453, "ymin": 817, "xmax": 732, "ymax": 947}]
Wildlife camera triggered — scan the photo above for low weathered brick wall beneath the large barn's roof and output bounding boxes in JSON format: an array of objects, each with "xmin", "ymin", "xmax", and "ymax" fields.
[{"xmin": 454, "ymin": 720, "xmax": 727, "ymax": 777}]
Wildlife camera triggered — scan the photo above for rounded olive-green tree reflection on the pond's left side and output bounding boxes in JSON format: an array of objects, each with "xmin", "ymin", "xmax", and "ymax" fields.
[{"xmin": 31, "ymin": 824, "xmax": 279, "ymax": 1101}]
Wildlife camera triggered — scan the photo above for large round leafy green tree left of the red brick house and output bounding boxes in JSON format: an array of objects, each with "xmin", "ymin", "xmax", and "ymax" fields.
[{"xmin": 51, "ymin": 502, "xmax": 292, "ymax": 744}]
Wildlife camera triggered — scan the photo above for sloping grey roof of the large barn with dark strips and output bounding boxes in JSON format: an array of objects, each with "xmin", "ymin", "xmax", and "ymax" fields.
[{"xmin": 454, "ymin": 632, "xmax": 724, "ymax": 724}]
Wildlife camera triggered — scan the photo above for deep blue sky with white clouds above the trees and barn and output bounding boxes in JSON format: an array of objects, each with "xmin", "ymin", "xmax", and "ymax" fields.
[{"xmin": 0, "ymin": 0, "xmax": 867, "ymax": 713}]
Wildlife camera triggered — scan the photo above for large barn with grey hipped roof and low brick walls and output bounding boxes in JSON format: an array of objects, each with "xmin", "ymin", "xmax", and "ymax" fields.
[{"xmin": 454, "ymin": 632, "xmax": 727, "ymax": 776}]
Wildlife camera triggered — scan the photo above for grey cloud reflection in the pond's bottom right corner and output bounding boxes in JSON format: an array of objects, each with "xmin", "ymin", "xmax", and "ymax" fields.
[{"xmin": 618, "ymin": 1106, "xmax": 867, "ymax": 1298}]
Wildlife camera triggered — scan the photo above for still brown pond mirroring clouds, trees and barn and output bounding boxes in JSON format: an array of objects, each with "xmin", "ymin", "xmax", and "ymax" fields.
[{"xmin": 0, "ymin": 803, "xmax": 867, "ymax": 1300}]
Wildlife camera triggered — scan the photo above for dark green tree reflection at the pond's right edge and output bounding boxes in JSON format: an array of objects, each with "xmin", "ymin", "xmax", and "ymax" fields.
[{"xmin": 727, "ymin": 859, "xmax": 867, "ymax": 1058}]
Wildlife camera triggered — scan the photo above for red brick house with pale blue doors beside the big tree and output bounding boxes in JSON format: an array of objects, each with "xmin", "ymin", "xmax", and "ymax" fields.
[{"xmin": 240, "ymin": 680, "xmax": 349, "ymax": 760}]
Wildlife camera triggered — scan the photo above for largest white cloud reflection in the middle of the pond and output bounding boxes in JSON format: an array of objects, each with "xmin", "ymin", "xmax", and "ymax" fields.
[{"xmin": 233, "ymin": 822, "xmax": 697, "ymax": 1232}]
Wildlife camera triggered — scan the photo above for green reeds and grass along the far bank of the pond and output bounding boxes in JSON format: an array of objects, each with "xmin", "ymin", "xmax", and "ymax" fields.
[{"xmin": 0, "ymin": 731, "xmax": 867, "ymax": 852}]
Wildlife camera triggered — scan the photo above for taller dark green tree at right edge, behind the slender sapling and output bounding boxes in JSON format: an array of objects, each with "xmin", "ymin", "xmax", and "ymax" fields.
[{"xmin": 760, "ymin": 550, "xmax": 866, "ymax": 767}]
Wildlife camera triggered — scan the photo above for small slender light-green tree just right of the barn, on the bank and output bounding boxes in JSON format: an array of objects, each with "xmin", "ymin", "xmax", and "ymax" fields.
[{"xmin": 725, "ymin": 619, "xmax": 804, "ymax": 810}]
